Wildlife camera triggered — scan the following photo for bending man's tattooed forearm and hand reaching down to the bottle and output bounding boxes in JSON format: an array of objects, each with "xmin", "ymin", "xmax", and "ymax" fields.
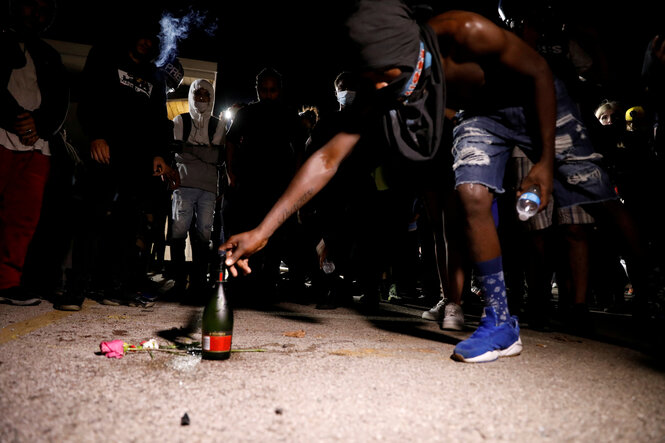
[{"xmin": 219, "ymin": 132, "xmax": 360, "ymax": 276}]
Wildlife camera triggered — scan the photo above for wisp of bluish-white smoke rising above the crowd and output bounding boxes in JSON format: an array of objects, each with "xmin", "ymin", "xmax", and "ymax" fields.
[{"xmin": 155, "ymin": 9, "xmax": 217, "ymax": 66}]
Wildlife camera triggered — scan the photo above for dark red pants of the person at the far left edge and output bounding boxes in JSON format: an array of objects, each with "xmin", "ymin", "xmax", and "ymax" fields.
[{"xmin": 0, "ymin": 145, "xmax": 51, "ymax": 289}]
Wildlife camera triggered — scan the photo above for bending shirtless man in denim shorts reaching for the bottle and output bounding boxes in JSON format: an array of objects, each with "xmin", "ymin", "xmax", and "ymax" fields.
[{"xmin": 221, "ymin": 0, "xmax": 628, "ymax": 363}]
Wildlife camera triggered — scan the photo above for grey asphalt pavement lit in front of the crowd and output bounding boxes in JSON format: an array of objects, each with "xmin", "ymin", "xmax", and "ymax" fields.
[{"xmin": 0, "ymin": 280, "xmax": 665, "ymax": 443}]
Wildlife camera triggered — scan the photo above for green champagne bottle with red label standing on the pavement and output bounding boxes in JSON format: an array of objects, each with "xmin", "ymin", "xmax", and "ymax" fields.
[{"xmin": 201, "ymin": 257, "xmax": 233, "ymax": 360}]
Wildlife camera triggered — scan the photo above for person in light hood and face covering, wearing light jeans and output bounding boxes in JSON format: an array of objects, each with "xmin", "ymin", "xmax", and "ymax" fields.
[{"xmin": 170, "ymin": 79, "xmax": 226, "ymax": 298}]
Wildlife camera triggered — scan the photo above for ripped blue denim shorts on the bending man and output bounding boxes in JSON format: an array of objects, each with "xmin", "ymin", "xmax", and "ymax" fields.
[{"xmin": 452, "ymin": 80, "xmax": 617, "ymax": 208}]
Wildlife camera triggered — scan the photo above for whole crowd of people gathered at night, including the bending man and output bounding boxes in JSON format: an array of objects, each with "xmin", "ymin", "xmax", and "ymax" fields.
[{"xmin": 0, "ymin": 0, "xmax": 665, "ymax": 363}]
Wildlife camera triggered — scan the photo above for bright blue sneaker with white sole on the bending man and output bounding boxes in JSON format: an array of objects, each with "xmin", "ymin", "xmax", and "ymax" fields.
[{"xmin": 452, "ymin": 307, "xmax": 522, "ymax": 363}]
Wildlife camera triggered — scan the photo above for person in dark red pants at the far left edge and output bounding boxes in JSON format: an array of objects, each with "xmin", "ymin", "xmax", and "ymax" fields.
[{"xmin": 0, "ymin": 0, "xmax": 69, "ymax": 305}]
